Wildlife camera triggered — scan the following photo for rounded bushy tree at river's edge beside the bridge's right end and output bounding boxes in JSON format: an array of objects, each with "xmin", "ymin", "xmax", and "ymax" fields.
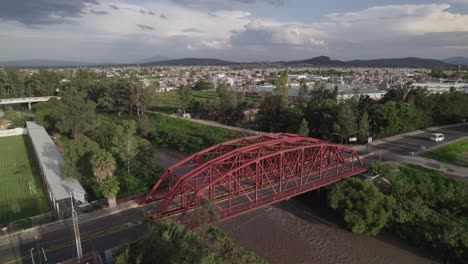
[{"xmin": 328, "ymin": 178, "xmax": 396, "ymax": 235}]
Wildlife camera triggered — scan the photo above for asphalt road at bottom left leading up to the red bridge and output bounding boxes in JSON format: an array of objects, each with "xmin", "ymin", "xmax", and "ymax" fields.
[{"xmin": 0, "ymin": 205, "xmax": 161, "ymax": 264}]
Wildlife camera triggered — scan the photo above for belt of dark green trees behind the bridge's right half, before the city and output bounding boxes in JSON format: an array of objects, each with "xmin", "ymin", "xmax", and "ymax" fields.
[{"xmin": 256, "ymin": 76, "xmax": 468, "ymax": 142}]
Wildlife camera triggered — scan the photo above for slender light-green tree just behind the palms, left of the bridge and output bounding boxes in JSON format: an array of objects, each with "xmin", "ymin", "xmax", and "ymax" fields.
[{"xmin": 112, "ymin": 120, "xmax": 149, "ymax": 173}]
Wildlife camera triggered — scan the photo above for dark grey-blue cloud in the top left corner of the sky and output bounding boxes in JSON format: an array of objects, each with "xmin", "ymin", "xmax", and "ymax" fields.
[{"xmin": 0, "ymin": 0, "xmax": 99, "ymax": 25}]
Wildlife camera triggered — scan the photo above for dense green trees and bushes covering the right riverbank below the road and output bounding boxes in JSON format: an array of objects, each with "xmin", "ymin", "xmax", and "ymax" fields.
[{"xmin": 329, "ymin": 164, "xmax": 468, "ymax": 263}]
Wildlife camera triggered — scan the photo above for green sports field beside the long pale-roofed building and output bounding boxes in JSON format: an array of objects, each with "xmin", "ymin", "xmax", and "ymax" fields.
[{"xmin": 0, "ymin": 136, "xmax": 50, "ymax": 225}]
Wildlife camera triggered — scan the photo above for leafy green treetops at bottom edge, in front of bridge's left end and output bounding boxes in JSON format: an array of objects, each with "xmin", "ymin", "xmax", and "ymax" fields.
[{"xmin": 114, "ymin": 219, "xmax": 266, "ymax": 264}]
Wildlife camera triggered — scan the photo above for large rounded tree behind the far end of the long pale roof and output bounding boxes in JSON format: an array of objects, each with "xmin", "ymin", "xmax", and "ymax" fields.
[{"xmin": 56, "ymin": 87, "xmax": 96, "ymax": 138}]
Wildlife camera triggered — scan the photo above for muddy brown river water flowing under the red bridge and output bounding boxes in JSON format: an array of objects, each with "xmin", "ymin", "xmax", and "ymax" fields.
[{"xmin": 158, "ymin": 149, "xmax": 436, "ymax": 264}]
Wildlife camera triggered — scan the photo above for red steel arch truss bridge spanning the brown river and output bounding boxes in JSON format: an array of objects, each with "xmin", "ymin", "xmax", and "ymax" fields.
[{"xmin": 140, "ymin": 133, "xmax": 367, "ymax": 223}]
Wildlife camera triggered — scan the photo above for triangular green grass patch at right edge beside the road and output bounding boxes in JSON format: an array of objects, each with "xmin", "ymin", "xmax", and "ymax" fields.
[{"xmin": 422, "ymin": 139, "xmax": 468, "ymax": 167}]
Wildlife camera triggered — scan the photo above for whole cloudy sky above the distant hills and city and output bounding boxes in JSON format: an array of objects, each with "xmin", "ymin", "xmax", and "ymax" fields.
[{"xmin": 0, "ymin": 0, "xmax": 468, "ymax": 63}]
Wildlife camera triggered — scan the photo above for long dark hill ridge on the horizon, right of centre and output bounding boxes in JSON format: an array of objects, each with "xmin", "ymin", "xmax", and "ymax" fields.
[{"xmin": 282, "ymin": 56, "xmax": 449, "ymax": 68}]
